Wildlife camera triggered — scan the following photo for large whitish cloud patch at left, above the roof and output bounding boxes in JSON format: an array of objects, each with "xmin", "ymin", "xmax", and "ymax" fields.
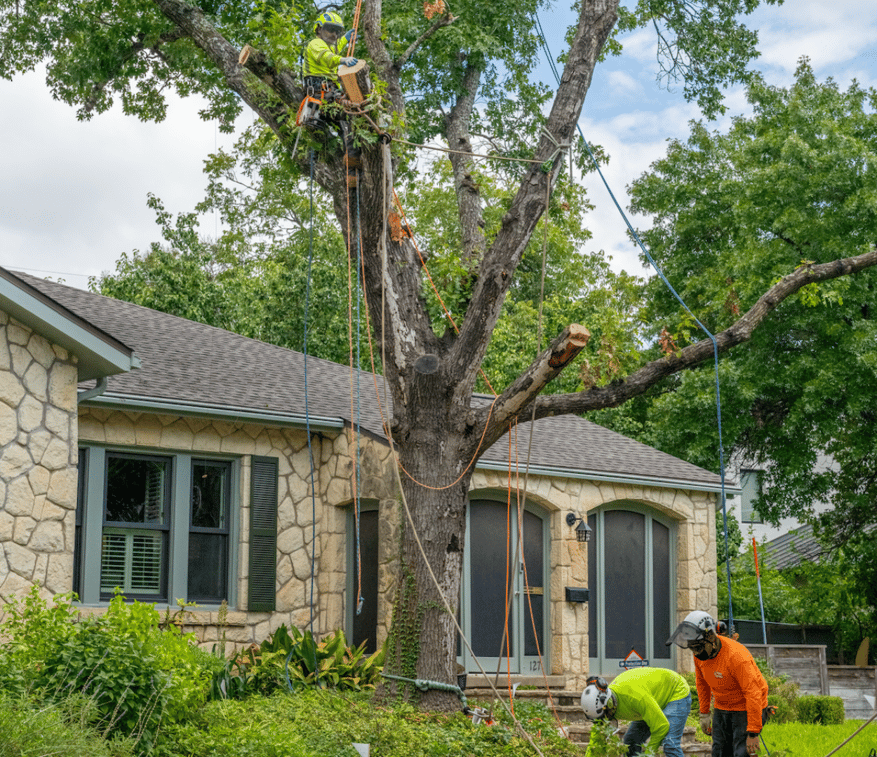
[{"xmin": 0, "ymin": 69, "xmax": 240, "ymax": 286}]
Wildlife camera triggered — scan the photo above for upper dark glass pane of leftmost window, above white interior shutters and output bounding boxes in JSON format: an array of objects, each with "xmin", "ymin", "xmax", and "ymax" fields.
[{"xmin": 104, "ymin": 455, "xmax": 170, "ymax": 525}]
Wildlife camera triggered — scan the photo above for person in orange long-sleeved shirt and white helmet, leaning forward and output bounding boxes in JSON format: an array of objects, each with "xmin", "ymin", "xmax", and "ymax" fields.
[{"xmin": 667, "ymin": 610, "xmax": 767, "ymax": 757}]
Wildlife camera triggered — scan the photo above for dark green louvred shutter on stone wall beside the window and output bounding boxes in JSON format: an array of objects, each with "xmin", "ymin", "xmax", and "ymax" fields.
[{"xmin": 247, "ymin": 456, "xmax": 278, "ymax": 612}]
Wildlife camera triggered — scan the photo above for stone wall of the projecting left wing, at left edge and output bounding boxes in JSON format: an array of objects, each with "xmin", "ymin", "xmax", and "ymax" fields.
[{"xmin": 0, "ymin": 312, "xmax": 77, "ymax": 599}]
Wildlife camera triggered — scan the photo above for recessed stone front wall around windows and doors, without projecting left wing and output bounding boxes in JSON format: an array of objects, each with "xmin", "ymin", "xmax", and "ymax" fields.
[{"xmin": 80, "ymin": 409, "xmax": 716, "ymax": 686}]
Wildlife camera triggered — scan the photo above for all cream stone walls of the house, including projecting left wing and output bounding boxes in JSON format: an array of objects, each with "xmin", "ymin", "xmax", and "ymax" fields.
[{"xmin": 0, "ymin": 322, "xmax": 716, "ymax": 685}]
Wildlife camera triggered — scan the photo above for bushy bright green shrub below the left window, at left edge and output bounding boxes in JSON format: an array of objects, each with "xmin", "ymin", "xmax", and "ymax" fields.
[{"xmin": 0, "ymin": 587, "xmax": 215, "ymax": 748}]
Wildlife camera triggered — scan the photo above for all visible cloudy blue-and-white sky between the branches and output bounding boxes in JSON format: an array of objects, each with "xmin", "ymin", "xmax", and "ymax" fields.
[{"xmin": 0, "ymin": 0, "xmax": 877, "ymax": 287}]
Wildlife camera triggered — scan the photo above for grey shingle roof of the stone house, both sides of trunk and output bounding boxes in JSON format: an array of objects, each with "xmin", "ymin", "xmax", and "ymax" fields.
[{"xmin": 15, "ymin": 273, "xmax": 720, "ymax": 487}]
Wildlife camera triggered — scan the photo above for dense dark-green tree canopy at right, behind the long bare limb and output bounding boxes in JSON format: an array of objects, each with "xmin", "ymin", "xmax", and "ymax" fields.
[{"xmin": 600, "ymin": 61, "xmax": 877, "ymax": 545}]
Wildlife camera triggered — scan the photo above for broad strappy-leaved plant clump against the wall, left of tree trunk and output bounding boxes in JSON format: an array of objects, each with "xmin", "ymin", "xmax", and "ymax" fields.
[{"xmin": 211, "ymin": 625, "xmax": 384, "ymax": 699}]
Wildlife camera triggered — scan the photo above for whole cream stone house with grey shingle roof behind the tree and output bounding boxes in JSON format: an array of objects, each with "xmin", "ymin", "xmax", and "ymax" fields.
[{"xmin": 0, "ymin": 269, "xmax": 720, "ymax": 685}]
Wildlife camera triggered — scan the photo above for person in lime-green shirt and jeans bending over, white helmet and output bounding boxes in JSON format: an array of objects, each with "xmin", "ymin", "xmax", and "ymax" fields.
[{"xmin": 582, "ymin": 667, "xmax": 691, "ymax": 757}]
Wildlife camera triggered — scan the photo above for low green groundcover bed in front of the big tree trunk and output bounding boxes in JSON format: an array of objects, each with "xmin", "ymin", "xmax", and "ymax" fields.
[{"xmin": 160, "ymin": 688, "xmax": 580, "ymax": 757}]
